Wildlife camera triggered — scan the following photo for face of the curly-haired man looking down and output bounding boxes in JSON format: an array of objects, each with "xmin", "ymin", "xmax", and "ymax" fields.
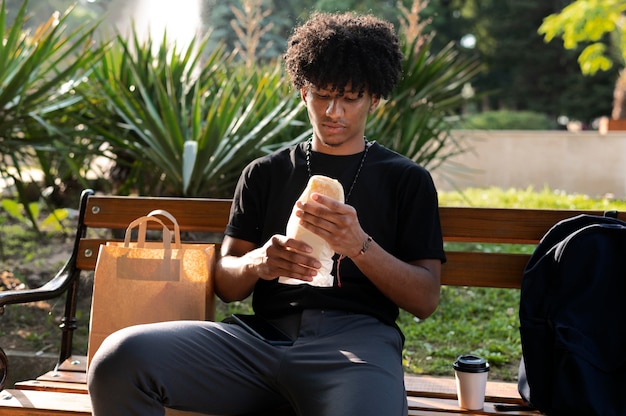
[{"xmin": 300, "ymin": 84, "xmax": 380, "ymax": 151}]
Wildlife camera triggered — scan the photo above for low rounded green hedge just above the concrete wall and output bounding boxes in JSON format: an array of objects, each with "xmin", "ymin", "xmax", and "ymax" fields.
[{"xmin": 455, "ymin": 110, "xmax": 558, "ymax": 130}]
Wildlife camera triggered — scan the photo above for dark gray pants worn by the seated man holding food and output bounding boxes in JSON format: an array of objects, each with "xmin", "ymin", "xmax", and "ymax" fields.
[{"xmin": 88, "ymin": 310, "xmax": 407, "ymax": 416}]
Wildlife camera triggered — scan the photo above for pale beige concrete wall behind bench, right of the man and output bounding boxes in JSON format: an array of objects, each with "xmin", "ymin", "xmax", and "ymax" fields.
[{"xmin": 432, "ymin": 130, "xmax": 626, "ymax": 199}]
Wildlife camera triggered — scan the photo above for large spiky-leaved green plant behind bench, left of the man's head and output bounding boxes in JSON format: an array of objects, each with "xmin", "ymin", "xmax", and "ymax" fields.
[{"xmin": 83, "ymin": 26, "xmax": 303, "ymax": 197}]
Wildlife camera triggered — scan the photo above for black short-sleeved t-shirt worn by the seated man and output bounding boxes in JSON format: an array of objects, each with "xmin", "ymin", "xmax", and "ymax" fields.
[{"xmin": 226, "ymin": 143, "xmax": 445, "ymax": 325}]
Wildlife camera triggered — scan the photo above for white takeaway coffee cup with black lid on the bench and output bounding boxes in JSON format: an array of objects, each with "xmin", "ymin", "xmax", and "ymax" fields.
[{"xmin": 453, "ymin": 355, "xmax": 489, "ymax": 410}]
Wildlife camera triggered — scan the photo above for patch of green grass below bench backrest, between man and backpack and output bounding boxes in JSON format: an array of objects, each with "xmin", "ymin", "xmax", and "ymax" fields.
[{"xmin": 399, "ymin": 287, "xmax": 520, "ymax": 380}]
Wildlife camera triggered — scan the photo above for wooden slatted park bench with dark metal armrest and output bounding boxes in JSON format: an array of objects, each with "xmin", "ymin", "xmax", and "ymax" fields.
[{"xmin": 0, "ymin": 191, "xmax": 623, "ymax": 416}]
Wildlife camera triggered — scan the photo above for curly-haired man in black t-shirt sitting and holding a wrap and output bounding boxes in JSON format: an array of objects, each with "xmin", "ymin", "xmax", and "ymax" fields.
[{"xmin": 89, "ymin": 13, "xmax": 445, "ymax": 416}]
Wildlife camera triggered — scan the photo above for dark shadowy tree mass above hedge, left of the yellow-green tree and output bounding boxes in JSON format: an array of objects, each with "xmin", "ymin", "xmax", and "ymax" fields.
[{"xmin": 436, "ymin": 0, "xmax": 614, "ymax": 122}]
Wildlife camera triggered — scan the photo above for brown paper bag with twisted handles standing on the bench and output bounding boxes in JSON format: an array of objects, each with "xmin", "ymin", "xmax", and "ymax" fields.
[{"xmin": 87, "ymin": 210, "xmax": 215, "ymax": 363}]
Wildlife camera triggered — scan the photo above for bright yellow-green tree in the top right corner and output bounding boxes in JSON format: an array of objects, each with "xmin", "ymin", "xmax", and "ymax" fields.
[{"xmin": 539, "ymin": 0, "xmax": 626, "ymax": 120}]
